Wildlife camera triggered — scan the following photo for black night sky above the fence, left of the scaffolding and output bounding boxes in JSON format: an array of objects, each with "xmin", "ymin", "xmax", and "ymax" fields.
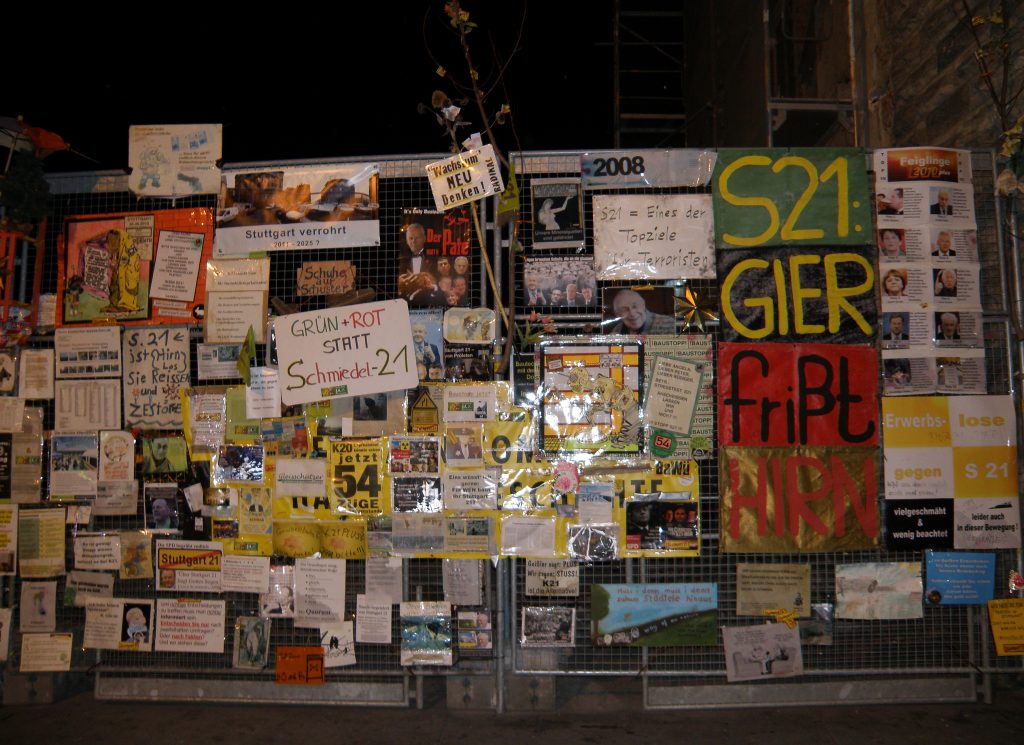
[{"xmin": 8, "ymin": 0, "xmax": 612, "ymax": 172}]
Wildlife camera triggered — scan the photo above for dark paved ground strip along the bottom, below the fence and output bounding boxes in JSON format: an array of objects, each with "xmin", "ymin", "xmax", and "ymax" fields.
[{"xmin": 0, "ymin": 679, "xmax": 1024, "ymax": 745}]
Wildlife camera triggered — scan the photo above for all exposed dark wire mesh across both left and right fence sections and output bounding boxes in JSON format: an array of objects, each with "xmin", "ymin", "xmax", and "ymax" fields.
[{"xmin": 2, "ymin": 152, "xmax": 1020, "ymax": 699}]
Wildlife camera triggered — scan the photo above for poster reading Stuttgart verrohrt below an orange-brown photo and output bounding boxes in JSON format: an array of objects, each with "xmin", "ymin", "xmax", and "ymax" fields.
[{"xmin": 214, "ymin": 163, "xmax": 380, "ymax": 257}]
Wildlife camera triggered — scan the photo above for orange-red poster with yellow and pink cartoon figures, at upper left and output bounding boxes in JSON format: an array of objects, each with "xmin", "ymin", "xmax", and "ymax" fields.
[{"xmin": 56, "ymin": 208, "xmax": 213, "ymax": 326}]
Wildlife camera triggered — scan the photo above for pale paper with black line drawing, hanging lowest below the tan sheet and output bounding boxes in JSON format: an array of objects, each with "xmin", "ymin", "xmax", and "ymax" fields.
[{"xmin": 722, "ymin": 623, "xmax": 804, "ymax": 683}]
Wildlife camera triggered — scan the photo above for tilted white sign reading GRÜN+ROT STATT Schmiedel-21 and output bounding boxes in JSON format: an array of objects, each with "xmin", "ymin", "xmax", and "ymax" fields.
[{"xmin": 276, "ymin": 300, "xmax": 418, "ymax": 405}]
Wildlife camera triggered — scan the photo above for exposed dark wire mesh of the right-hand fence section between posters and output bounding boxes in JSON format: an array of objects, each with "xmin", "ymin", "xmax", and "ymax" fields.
[{"xmin": 510, "ymin": 151, "xmax": 1020, "ymax": 686}]
